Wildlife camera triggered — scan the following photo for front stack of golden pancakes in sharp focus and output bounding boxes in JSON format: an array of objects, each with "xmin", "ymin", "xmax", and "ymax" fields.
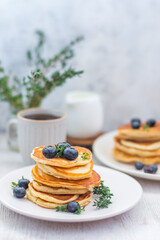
[{"xmin": 26, "ymin": 146, "xmax": 101, "ymax": 208}]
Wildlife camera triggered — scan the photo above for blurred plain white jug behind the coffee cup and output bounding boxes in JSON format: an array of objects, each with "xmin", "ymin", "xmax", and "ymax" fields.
[{"xmin": 65, "ymin": 91, "xmax": 103, "ymax": 139}]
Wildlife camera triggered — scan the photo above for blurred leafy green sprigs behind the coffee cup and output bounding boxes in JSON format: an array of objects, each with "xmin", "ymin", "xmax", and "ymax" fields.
[{"xmin": 0, "ymin": 31, "xmax": 83, "ymax": 113}]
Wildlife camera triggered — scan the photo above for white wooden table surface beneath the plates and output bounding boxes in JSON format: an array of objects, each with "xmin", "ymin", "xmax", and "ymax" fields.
[{"xmin": 0, "ymin": 134, "xmax": 160, "ymax": 240}]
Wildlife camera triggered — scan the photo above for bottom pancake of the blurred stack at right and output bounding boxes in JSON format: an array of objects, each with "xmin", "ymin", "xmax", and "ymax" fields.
[{"xmin": 113, "ymin": 148, "xmax": 160, "ymax": 165}]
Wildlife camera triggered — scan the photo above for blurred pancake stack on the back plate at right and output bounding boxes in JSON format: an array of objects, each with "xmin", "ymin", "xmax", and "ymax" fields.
[{"xmin": 113, "ymin": 123, "xmax": 160, "ymax": 165}]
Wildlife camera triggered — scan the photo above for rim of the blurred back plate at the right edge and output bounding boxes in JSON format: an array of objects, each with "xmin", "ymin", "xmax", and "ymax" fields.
[{"xmin": 92, "ymin": 130, "xmax": 160, "ymax": 181}]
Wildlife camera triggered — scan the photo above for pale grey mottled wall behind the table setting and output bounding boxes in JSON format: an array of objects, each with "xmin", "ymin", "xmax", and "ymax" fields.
[{"xmin": 0, "ymin": 0, "xmax": 160, "ymax": 130}]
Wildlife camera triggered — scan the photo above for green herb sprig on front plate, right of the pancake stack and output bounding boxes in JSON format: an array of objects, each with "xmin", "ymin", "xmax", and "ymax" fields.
[{"xmin": 93, "ymin": 181, "xmax": 113, "ymax": 208}]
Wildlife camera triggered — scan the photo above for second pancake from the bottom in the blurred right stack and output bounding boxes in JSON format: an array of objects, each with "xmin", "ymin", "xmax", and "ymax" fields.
[{"xmin": 115, "ymin": 138, "xmax": 160, "ymax": 157}]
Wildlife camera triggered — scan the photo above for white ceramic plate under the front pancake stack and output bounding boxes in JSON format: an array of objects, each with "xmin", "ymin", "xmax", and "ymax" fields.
[{"xmin": 0, "ymin": 165, "xmax": 142, "ymax": 222}]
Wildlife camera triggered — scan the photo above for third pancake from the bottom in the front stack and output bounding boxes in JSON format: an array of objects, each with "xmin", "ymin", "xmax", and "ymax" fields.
[{"xmin": 32, "ymin": 180, "xmax": 88, "ymax": 194}]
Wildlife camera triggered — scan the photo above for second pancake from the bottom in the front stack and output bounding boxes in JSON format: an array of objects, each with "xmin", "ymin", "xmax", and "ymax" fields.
[{"xmin": 29, "ymin": 182, "xmax": 79, "ymax": 204}]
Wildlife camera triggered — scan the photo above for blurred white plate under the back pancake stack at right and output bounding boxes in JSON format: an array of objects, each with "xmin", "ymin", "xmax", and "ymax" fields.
[{"xmin": 93, "ymin": 131, "xmax": 160, "ymax": 181}]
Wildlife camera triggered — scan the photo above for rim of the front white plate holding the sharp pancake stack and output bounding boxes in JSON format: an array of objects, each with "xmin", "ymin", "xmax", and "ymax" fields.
[{"xmin": 0, "ymin": 164, "xmax": 143, "ymax": 223}]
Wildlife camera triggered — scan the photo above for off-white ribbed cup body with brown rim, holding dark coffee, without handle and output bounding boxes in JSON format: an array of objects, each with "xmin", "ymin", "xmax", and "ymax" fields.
[{"xmin": 17, "ymin": 108, "xmax": 66, "ymax": 165}]
